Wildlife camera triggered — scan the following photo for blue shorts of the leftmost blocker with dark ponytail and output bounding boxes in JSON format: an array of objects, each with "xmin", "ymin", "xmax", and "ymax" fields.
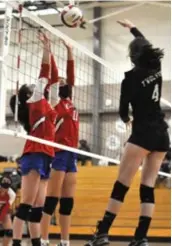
[{"xmin": 20, "ymin": 153, "xmax": 52, "ymax": 179}]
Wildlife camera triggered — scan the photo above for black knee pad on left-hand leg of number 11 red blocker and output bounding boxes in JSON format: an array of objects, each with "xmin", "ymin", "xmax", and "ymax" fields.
[{"xmin": 43, "ymin": 196, "xmax": 59, "ymax": 215}]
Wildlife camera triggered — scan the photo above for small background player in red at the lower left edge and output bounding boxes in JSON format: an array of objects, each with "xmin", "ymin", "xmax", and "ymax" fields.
[{"xmin": 0, "ymin": 176, "xmax": 16, "ymax": 246}]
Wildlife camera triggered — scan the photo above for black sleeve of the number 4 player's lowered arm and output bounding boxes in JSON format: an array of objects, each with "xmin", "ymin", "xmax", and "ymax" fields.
[{"xmin": 119, "ymin": 79, "xmax": 130, "ymax": 123}]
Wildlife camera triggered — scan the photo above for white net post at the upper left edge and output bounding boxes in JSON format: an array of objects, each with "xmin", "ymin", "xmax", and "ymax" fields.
[{"xmin": 0, "ymin": 3, "xmax": 12, "ymax": 128}]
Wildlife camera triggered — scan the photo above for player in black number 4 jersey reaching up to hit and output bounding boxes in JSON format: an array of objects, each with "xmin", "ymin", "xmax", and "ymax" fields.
[{"xmin": 85, "ymin": 20, "xmax": 169, "ymax": 246}]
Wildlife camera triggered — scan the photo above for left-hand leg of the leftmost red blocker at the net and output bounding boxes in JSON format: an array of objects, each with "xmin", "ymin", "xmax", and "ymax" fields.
[{"xmin": 13, "ymin": 170, "xmax": 40, "ymax": 246}]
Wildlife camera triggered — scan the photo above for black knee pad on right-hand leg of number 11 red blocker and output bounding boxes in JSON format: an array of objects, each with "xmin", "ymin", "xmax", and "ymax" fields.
[{"xmin": 59, "ymin": 197, "xmax": 74, "ymax": 215}]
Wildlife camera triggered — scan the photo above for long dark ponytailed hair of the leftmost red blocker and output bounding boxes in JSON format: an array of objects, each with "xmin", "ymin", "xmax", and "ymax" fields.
[{"xmin": 10, "ymin": 84, "xmax": 32, "ymax": 133}]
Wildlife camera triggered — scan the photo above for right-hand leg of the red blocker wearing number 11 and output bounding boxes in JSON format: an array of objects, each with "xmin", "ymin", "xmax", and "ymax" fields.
[{"xmin": 59, "ymin": 172, "xmax": 76, "ymax": 246}]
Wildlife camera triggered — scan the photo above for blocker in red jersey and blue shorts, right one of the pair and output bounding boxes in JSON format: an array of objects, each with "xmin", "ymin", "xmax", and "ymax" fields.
[{"xmin": 41, "ymin": 41, "xmax": 79, "ymax": 246}]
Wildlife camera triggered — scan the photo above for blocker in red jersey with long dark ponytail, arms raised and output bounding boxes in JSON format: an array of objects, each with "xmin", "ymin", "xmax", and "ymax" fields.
[{"xmin": 10, "ymin": 35, "xmax": 56, "ymax": 246}]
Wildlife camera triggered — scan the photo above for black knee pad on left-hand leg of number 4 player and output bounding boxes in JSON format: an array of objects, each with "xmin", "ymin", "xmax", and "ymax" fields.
[{"xmin": 111, "ymin": 181, "xmax": 129, "ymax": 202}]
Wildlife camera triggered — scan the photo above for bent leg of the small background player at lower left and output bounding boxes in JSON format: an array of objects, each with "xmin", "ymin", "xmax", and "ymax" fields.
[{"xmin": 2, "ymin": 213, "xmax": 13, "ymax": 246}]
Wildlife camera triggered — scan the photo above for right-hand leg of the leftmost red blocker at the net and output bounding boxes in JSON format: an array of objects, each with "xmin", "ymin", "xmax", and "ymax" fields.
[{"xmin": 28, "ymin": 180, "xmax": 48, "ymax": 246}]
